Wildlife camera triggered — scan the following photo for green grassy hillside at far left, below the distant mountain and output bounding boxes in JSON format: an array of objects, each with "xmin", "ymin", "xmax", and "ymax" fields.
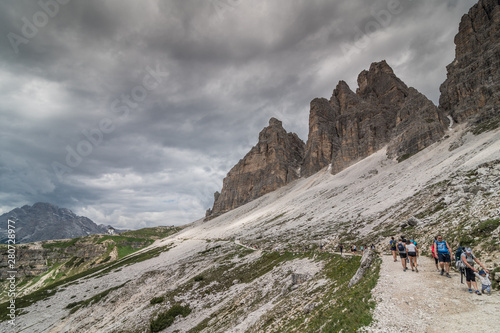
[{"xmin": 0, "ymin": 227, "xmax": 181, "ymax": 320}]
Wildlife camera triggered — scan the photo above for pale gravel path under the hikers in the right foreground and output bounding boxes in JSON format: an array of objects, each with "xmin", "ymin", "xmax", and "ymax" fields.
[{"xmin": 365, "ymin": 256, "xmax": 500, "ymax": 333}]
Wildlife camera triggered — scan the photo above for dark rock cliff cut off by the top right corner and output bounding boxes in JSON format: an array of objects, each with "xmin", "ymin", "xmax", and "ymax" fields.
[{"xmin": 439, "ymin": 0, "xmax": 500, "ymax": 122}]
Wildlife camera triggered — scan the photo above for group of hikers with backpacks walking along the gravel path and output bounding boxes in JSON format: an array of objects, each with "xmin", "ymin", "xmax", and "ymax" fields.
[{"xmin": 389, "ymin": 235, "xmax": 491, "ymax": 295}]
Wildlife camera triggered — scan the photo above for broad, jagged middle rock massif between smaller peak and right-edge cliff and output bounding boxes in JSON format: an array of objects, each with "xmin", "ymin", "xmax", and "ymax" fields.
[{"xmin": 302, "ymin": 61, "xmax": 445, "ymax": 177}]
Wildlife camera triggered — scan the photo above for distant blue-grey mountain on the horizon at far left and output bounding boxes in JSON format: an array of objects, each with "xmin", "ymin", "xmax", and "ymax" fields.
[{"xmin": 0, "ymin": 202, "xmax": 118, "ymax": 244}]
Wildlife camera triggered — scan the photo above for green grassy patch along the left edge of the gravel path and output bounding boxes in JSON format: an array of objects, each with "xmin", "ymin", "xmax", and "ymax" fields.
[{"xmin": 253, "ymin": 253, "xmax": 381, "ymax": 332}]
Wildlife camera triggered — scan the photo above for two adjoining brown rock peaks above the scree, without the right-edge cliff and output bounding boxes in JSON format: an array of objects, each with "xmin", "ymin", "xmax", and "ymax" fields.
[{"xmin": 206, "ymin": 61, "xmax": 447, "ymax": 220}]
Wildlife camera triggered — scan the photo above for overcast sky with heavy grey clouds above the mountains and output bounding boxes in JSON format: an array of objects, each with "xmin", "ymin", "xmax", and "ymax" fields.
[{"xmin": 0, "ymin": 0, "xmax": 476, "ymax": 228}]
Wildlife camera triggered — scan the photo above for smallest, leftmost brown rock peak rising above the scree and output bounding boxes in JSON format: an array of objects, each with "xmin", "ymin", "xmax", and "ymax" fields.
[{"xmin": 206, "ymin": 118, "xmax": 305, "ymax": 219}]
